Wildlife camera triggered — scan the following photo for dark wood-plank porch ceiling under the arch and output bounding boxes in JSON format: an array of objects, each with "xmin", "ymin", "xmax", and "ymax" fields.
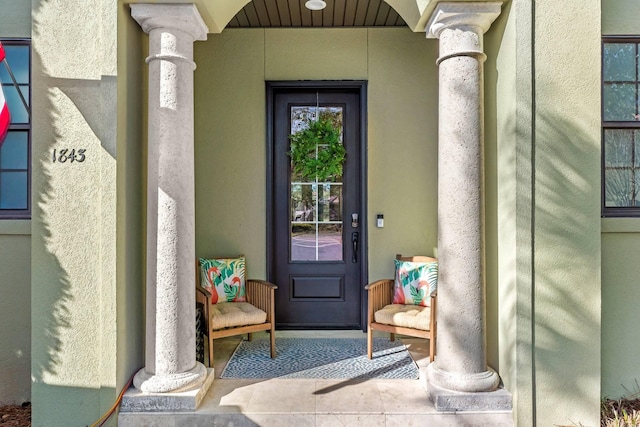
[{"xmin": 227, "ymin": 0, "xmax": 407, "ymax": 28}]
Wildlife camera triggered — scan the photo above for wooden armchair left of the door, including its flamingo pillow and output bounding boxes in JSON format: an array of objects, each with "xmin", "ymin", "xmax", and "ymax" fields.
[{"xmin": 196, "ymin": 255, "xmax": 278, "ymax": 367}]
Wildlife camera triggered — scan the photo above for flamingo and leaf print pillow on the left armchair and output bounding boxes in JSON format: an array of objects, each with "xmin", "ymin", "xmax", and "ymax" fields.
[{"xmin": 200, "ymin": 257, "xmax": 247, "ymax": 304}]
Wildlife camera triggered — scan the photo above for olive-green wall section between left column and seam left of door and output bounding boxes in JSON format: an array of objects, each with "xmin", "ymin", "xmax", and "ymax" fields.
[{"xmin": 194, "ymin": 30, "xmax": 266, "ymax": 278}]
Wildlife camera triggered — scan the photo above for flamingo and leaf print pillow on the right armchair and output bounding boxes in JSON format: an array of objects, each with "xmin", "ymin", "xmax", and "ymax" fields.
[{"xmin": 393, "ymin": 259, "xmax": 438, "ymax": 307}]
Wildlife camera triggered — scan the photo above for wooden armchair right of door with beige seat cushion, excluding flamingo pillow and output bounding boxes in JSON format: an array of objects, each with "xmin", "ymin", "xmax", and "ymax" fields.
[{"xmin": 365, "ymin": 255, "xmax": 437, "ymax": 362}]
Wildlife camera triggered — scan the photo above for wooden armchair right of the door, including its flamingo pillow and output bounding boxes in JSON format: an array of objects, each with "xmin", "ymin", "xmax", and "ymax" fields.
[{"xmin": 365, "ymin": 255, "xmax": 438, "ymax": 362}]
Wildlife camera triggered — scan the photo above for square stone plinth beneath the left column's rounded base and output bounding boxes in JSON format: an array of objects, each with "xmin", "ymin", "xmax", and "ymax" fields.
[{"xmin": 120, "ymin": 363, "xmax": 214, "ymax": 412}]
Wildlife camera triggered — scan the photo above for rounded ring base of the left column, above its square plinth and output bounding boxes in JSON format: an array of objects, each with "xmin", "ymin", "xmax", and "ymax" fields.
[{"xmin": 133, "ymin": 362, "xmax": 207, "ymax": 393}]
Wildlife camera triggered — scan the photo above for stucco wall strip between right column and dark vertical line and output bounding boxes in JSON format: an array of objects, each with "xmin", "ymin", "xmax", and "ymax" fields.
[{"xmin": 486, "ymin": 1, "xmax": 535, "ymax": 425}]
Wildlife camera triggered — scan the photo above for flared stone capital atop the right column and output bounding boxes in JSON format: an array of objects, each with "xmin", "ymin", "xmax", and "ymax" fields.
[{"xmin": 426, "ymin": 1, "xmax": 502, "ymax": 39}]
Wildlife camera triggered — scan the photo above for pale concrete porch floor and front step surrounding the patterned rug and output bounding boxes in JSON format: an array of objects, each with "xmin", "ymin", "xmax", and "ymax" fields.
[{"xmin": 118, "ymin": 331, "xmax": 513, "ymax": 427}]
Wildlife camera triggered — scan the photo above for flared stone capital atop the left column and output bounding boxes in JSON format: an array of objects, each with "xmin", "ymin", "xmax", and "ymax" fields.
[{"xmin": 130, "ymin": 3, "xmax": 209, "ymax": 41}]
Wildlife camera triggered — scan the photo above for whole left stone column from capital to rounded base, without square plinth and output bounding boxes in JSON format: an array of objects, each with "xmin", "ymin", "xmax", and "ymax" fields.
[{"xmin": 131, "ymin": 4, "xmax": 208, "ymax": 393}]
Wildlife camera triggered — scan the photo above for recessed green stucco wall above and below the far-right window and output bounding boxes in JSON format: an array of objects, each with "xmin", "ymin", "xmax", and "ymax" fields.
[{"xmin": 602, "ymin": 0, "xmax": 640, "ymax": 399}]
